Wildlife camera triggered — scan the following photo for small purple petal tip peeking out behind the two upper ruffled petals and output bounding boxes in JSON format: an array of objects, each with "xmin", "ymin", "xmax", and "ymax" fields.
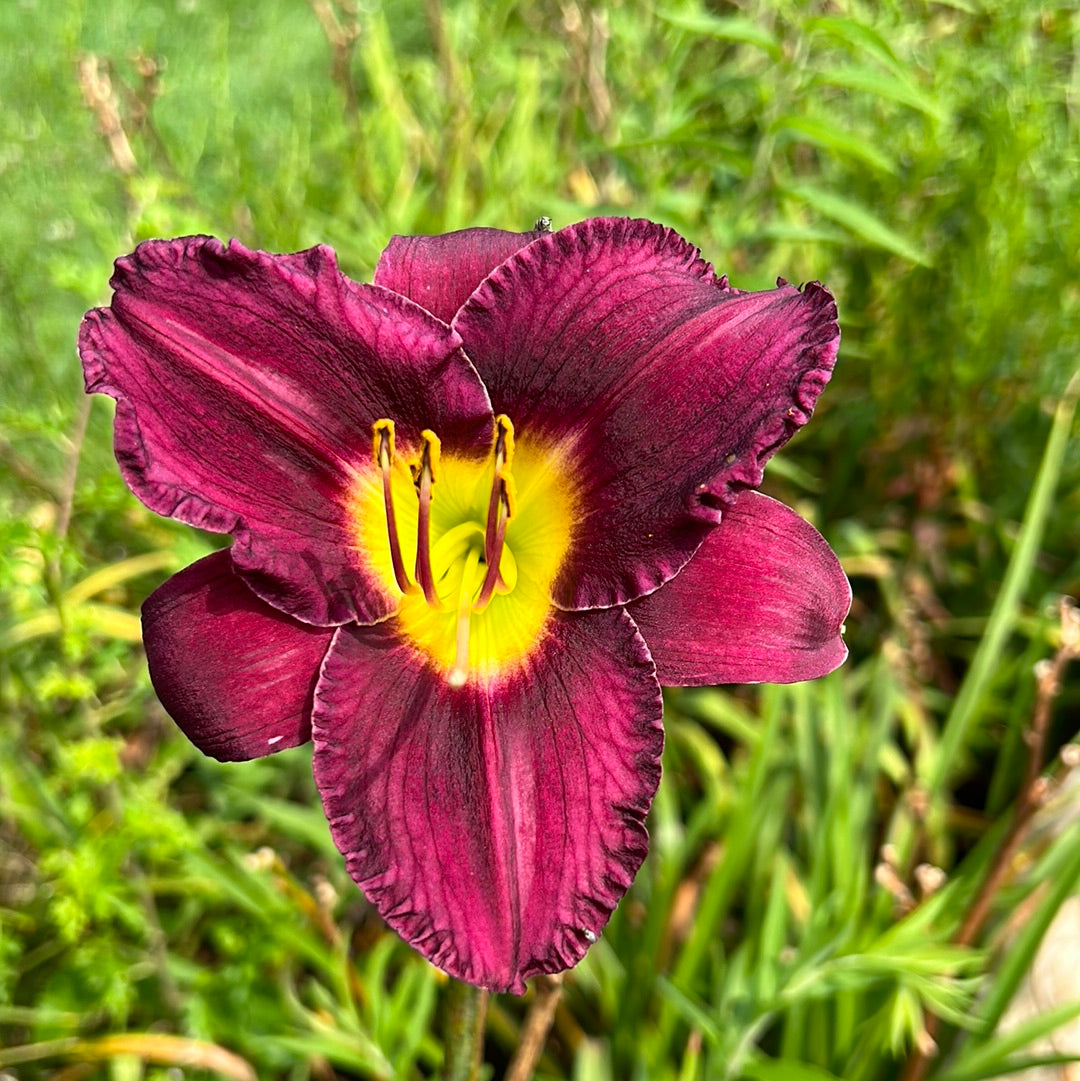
[{"xmin": 374, "ymin": 229, "xmax": 543, "ymax": 323}]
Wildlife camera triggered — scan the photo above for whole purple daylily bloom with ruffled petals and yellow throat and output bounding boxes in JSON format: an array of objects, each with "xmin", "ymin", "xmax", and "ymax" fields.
[{"xmin": 79, "ymin": 218, "xmax": 850, "ymax": 992}]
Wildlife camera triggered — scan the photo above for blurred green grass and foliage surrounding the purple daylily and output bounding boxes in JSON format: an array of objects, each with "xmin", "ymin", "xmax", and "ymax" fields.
[{"xmin": 0, "ymin": 0, "xmax": 1080, "ymax": 1081}]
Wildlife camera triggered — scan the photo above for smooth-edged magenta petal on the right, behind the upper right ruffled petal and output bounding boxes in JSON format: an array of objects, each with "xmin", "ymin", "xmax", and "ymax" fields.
[{"xmin": 627, "ymin": 492, "xmax": 851, "ymax": 686}]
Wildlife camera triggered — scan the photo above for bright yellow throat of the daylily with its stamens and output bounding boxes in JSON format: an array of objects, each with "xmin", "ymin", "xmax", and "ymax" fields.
[{"xmin": 352, "ymin": 416, "xmax": 574, "ymax": 686}]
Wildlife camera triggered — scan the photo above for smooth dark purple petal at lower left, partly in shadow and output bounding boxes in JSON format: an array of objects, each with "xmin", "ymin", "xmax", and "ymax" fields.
[{"xmin": 143, "ymin": 551, "xmax": 334, "ymax": 762}]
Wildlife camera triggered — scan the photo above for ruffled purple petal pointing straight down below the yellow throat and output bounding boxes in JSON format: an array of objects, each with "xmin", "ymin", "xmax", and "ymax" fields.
[{"xmin": 314, "ymin": 609, "xmax": 663, "ymax": 993}]
